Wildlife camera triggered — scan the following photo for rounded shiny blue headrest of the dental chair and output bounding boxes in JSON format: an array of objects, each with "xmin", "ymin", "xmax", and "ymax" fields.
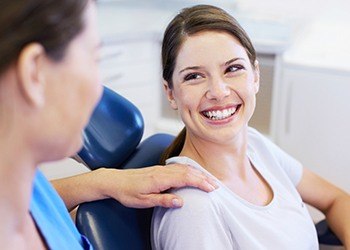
[{"xmin": 77, "ymin": 87, "xmax": 144, "ymax": 169}]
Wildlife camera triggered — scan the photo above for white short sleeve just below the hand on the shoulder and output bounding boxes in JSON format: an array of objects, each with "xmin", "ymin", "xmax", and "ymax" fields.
[{"xmin": 152, "ymin": 188, "xmax": 235, "ymax": 250}]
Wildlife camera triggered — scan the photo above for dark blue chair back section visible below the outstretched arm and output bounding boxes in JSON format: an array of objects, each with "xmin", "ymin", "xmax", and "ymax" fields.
[{"xmin": 76, "ymin": 199, "xmax": 153, "ymax": 250}]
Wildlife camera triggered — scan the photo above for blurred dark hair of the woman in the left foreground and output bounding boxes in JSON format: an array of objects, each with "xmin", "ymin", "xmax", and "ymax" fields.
[{"xmin": 0, "ymin": 0, "xmax": 89, "ymax": 74}]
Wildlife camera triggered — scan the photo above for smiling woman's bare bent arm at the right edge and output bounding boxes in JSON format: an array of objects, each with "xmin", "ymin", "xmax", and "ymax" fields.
[{"xmin": 297, "ymin": 168, "xmax": 350, "ymax": 249}]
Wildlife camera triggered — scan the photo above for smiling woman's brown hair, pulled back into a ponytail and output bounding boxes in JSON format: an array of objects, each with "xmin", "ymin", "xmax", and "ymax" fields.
[{"xmin": 161, "ymin": 5, "xmax": 256, "ymax": 164}]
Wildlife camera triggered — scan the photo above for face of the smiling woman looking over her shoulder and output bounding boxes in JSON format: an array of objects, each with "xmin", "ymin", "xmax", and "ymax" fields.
[{"xmin": 165, "ymin": 31, "xmax": 259, "ymax": 145}]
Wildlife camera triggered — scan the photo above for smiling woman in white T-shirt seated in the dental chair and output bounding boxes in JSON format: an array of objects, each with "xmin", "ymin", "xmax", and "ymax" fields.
[{"xmin": 152, "ymin": 5, "xmax": 350, "ymax": 249}]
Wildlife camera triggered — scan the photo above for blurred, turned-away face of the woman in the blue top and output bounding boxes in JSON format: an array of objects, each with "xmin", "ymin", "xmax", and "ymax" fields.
[{"xmin": 45, "ymin": 1, "xmax": 102, "ymax": 158}]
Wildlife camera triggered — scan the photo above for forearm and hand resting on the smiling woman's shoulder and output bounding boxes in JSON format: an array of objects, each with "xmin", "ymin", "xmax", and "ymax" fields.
[{"xmin": 52, "ymin": 164, "xmax": 217, "ymax": 211}]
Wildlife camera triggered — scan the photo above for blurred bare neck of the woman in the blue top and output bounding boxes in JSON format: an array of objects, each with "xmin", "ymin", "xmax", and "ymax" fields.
[{"xmin": 0, "ymin": 67, "xmax": 45, "ymax": 249}]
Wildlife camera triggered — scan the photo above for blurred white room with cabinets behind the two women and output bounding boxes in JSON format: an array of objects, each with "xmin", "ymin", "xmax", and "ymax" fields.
[{"xmin": 41, "ymin": 0, "xmax": 350, "ymax": 235}]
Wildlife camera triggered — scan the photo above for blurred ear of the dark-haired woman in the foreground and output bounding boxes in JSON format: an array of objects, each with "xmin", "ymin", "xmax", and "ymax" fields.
[{"xmin": 17, "ymin": 43, "xmax": 47, "ymax": 107}]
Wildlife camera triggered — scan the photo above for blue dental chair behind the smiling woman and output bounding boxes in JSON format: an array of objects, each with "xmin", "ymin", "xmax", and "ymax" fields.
[{"xmin": 76, "ymin": 88, "xmax": 341, "ymax": 250}]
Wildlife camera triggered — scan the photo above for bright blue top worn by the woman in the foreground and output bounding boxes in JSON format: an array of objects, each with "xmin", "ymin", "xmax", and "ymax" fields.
[{"xmin": 30, "ymin": 170, "xmax": 92, "ymax": 250}]
